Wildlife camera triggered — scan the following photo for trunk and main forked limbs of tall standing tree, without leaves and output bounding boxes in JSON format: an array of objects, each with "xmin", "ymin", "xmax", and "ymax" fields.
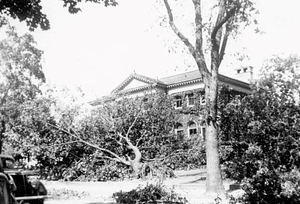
[{"xmin": 163, "ymin": 0, "xmax": 230, "ymax": 194}]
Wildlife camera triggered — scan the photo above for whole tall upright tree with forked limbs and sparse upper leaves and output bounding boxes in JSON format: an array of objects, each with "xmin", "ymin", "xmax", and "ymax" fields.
[{"xmin": 163, "ymin": 0, "xmax": 255, "ymax": 194}]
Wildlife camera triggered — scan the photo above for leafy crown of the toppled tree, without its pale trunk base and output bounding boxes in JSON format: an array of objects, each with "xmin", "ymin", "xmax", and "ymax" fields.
[{"xmin": 15, "ymin": 92, "xmax": 183, "ymax": 180}]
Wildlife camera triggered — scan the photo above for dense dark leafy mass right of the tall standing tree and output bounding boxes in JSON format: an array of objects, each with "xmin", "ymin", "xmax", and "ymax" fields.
[{"xmin": 221, "ymin": 56, "xmax": 300, "ymax": 203}]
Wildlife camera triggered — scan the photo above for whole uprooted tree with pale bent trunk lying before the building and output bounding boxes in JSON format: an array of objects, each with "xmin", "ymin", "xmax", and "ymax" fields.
[{"xmin": 11, "ymin": 91, "xmax": 179, "ymax": 178}]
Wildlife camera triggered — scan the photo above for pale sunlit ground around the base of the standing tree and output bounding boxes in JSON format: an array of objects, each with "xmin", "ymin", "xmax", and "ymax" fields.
[{"xmin": 44, "ymin": 169, "xmax": 241, "ymax": 204}]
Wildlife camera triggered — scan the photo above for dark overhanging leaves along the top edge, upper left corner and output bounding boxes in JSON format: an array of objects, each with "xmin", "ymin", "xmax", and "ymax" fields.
[{"xmin": 0, "ymin": 0, "xmax": 117, "ymax": 31}]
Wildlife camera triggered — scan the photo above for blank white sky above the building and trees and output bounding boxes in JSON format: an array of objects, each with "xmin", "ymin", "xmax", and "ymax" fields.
[{"xmin": 0, "ymin": 0, "xmax": 300, "ymax": 100}]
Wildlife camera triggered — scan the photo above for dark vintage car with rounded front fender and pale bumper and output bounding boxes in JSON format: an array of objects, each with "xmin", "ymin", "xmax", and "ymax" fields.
[{"xmin": 0, "ymin": 155, "xmax": 47, "ymax": 204}]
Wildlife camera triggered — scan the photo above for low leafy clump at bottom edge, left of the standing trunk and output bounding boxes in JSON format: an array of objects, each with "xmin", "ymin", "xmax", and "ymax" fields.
[{"xmin": 113, "ymin": 184, "xmax": 188, "ymax": 204}]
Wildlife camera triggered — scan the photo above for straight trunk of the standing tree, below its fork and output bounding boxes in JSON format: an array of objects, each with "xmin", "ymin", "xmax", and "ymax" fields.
[{"xmin": 204, "ymin": 74, "xmax": 225, "ymax": 195}]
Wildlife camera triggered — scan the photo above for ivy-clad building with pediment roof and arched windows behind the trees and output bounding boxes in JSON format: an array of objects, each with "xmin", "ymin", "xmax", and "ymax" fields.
[{"xmin": 91, "ymin": 70, "xmax": 251, "ymax": 139}]
